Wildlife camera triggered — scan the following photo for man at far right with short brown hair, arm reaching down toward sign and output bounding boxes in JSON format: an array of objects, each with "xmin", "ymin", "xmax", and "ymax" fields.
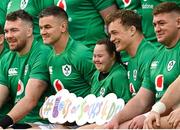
[{"xmin": 106, "ymin": 2, "xmax": 180, "ymax": 128}]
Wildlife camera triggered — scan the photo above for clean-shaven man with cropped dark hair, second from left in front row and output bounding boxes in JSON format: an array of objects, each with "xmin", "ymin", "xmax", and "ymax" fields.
[{"xmin": 39, "ymin": 6, "xmax": 95, "ymax": 97}]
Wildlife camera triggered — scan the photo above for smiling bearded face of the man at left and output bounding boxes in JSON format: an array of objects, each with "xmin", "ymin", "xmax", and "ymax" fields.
[{"xmin": 4, "ymin": 19, "xmax": 32, "ymax": 52}]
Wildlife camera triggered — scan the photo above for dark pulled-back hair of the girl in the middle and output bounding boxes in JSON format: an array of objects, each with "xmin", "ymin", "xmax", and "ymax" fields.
[{"xmin": 96, "ymin": 38, "xmax": 123, "ymax": 64}]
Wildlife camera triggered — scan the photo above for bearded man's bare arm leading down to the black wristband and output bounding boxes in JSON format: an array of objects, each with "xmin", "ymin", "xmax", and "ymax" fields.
[{"xmin": 0, "ymin": 79, "xmax": 47, "ymax": 127}]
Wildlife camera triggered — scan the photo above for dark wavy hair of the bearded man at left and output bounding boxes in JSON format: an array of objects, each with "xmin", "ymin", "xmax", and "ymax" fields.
[{"xmin": 6, "ymin": 10, "xmax": 33, "ymax": 27}]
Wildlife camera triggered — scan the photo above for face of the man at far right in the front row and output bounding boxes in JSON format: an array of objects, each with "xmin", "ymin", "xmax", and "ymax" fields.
[{"xmin": 153, "ymin": 12, "xmax": 180, "ymax": 47}]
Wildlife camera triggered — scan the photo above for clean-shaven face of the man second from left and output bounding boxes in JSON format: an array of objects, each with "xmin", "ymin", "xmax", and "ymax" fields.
[{"xmin": 39, "ymin": 16, "xmax": 66, "ymax": 45}]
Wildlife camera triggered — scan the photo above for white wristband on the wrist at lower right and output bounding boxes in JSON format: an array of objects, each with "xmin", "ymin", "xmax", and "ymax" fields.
[{"xmin": 151, "ymin": 101, "xmax": 166, "ymax": 114}]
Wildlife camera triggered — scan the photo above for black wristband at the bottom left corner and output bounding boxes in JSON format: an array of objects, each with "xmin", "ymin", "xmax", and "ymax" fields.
[{"xmin": 0, "ymin": 115, "xmax": 13, "ymax": 129}]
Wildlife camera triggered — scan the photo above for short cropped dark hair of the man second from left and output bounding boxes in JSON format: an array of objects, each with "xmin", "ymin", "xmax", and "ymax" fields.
[{"xmin": 39, "ymin": 6, "xmax": 68, "ymax": 21}]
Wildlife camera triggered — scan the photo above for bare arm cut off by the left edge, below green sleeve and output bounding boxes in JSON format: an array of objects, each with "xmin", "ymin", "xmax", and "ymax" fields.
[{"xmin": 0, "ymin": 84, "xmax": 9, "ymax": 108}]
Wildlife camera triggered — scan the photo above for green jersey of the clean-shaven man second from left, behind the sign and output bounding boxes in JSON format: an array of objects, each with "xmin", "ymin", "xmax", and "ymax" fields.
[{"xmin": 48, "ymin": 37, "xmax": 95, "ymax": 97}]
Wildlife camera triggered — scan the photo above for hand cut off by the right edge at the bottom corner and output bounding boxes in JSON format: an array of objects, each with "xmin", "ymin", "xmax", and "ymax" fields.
[{"xmin": 167, "ymin": 108, "xmax": 180, "ymax": 129}]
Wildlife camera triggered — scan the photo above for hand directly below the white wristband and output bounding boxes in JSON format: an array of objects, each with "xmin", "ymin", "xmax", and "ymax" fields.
[{"xmin": 143, "ymin": 111, "xmax": 160, "ymax": 129}]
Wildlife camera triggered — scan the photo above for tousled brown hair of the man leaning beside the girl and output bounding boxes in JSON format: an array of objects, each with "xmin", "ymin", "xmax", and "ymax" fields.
[{"xmin": 106, "ymin": 9, "xmax": 142, "ymax": 32}]
